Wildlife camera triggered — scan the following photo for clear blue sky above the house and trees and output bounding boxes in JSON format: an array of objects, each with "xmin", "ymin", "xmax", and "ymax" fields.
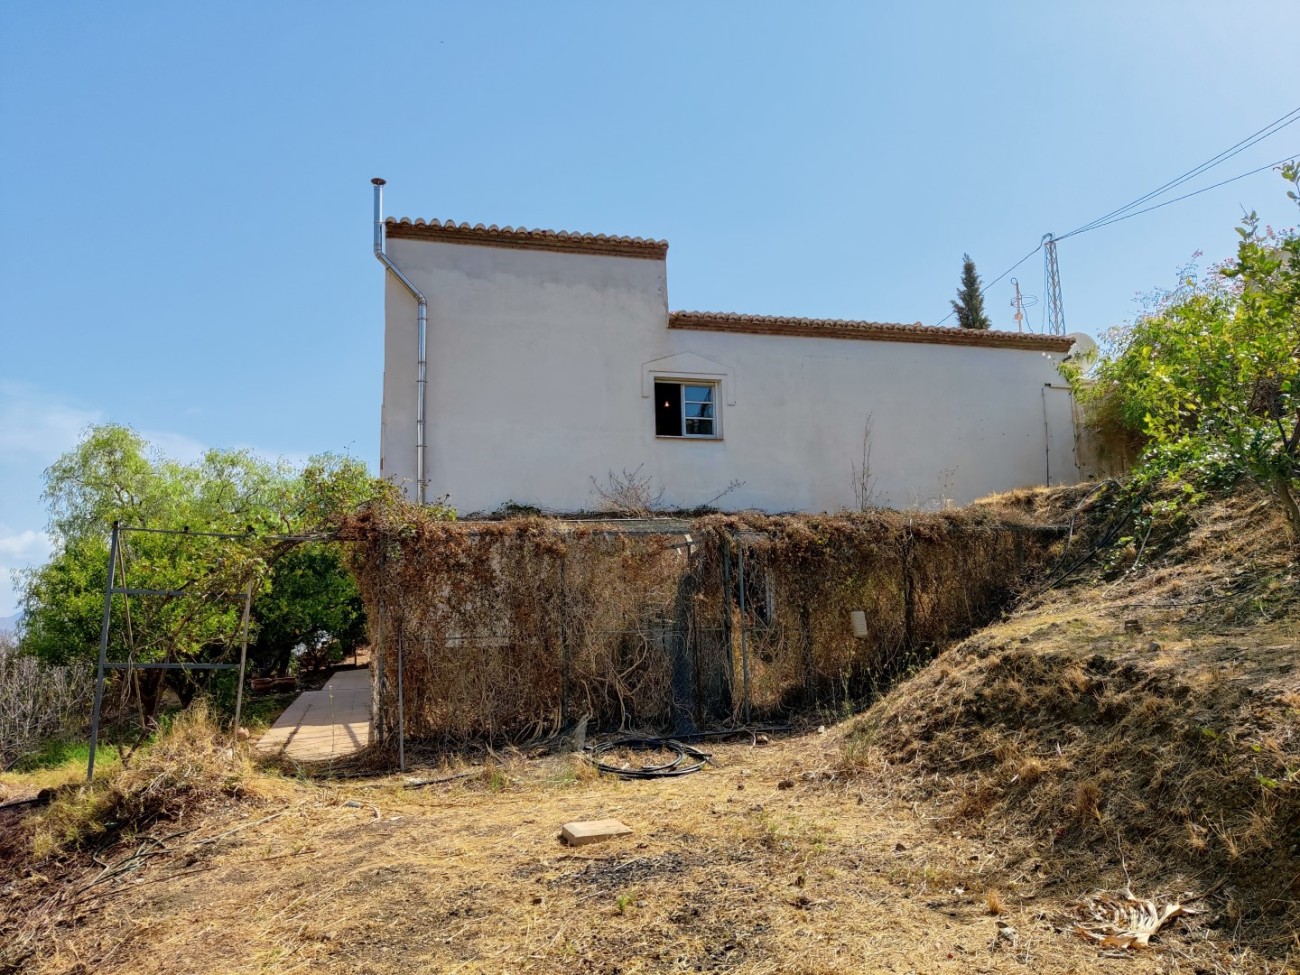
[{"xmin": 0, "ymin": 0, "xmax": 1300, "ymax": 615}]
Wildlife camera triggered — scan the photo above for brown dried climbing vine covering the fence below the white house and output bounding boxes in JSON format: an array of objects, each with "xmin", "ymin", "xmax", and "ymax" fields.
[{"xmin": 343, "ymin": 502, "xmax": 1053, "ymax": 742}]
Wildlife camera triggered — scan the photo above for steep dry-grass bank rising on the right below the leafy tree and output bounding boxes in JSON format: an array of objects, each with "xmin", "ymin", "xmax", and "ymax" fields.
[{"xmin": 845, "ymin": 493, "xmax": 1300, "ymax": 953}]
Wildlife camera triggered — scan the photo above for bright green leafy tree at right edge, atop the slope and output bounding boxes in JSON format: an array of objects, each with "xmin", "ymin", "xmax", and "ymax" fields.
[{"xmin": 1079, "ymin": 166, "xmax": 1300, "ymax": 536}]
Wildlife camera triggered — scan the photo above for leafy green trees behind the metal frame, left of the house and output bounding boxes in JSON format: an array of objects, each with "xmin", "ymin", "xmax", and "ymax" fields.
[{"xmin": 22, "ymin": 424, "xmax": 391, "ymax": 714}]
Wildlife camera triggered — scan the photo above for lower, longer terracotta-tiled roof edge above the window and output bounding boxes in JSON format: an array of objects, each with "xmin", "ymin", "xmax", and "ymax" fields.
[{"xmin": 668, "ymin": 312, "xmax": 1071, "ymax": 352}]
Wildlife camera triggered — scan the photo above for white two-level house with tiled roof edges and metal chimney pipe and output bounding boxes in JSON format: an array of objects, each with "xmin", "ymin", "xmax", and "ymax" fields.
[{"xmin": 374, "ymin": 182, "xmax": 1082, "ymax": 512}]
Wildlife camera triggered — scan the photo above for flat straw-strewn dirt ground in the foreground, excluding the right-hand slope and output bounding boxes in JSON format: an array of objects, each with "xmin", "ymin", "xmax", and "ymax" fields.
[{"xmin": 0, "ymin": 729, "xmax": 1263, "ymax": 975}]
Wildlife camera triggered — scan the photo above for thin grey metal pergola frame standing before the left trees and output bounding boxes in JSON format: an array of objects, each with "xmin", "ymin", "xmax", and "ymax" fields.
[{"xmin": 86, "ymin": 521, "xmax": 335, "ymax": 783}]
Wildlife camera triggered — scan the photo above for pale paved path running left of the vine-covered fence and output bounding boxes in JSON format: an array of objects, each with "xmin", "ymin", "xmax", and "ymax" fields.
[{"xmin": 257, "ymin": 670, "xmax": 371, "ymax": 762}]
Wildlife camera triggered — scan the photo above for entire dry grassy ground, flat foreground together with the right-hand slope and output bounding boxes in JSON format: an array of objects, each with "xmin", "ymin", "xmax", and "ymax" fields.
[{"xmin": 0, "ymin": 495, "xmax": 1300, "ymax": 975}]
